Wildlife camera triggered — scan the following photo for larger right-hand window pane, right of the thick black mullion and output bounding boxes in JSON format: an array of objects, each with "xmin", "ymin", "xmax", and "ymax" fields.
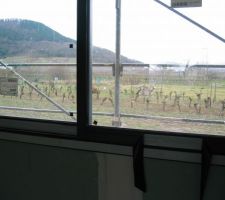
[{"xmin": 91, "ymin": 0, "xmax": 225, "ymax": 135}]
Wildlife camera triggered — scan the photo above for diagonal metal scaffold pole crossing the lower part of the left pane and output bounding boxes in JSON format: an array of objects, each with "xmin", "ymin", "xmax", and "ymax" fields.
[{"xmin": 0, "ymin": 60, "xmax": 76, "ymax": 120}]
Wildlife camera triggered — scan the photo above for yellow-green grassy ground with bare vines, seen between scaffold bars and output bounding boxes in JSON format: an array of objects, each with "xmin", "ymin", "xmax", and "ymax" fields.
[{"xmin": 0, "ymin": 58, "xmax": 225, "ymax": 134}]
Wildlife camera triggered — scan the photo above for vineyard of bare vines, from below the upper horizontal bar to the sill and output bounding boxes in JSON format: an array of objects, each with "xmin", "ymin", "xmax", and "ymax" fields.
[{"xmin": 0, "ymin": 64, "xmax": 225, "ymax": 134}]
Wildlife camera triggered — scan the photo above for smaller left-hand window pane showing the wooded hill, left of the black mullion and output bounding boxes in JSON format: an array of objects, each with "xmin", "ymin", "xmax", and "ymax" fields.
[{"xmin": 0, "ymin": 0, "xmax": 77, "ymax": 121}]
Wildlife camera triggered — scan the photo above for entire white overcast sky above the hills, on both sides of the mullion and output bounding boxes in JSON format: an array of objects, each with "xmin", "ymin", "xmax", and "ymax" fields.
[{"xmin": 0, "ymin": 0, "xmax": 225, "ymax": 64}]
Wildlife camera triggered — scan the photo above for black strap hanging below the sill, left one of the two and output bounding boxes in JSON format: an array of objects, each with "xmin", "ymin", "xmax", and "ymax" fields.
[{"xmin": 133, "ymin": 135, "xmax": 146, "ymax": 192}]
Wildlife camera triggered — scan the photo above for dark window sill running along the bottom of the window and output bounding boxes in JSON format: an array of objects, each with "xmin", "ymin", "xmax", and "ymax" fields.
[{"xmin": 0, "ymin": 116, "xmax": 225, "ymax": 166}]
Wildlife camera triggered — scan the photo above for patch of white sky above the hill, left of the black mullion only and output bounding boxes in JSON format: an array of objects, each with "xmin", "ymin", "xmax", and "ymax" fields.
[{"xmin": 0, "ymin": 0, "xmax": 77, "ymax": 39}]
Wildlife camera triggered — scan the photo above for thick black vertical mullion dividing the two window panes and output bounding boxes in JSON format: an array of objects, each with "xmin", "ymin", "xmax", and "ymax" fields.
[{"xmin": 77, "ymin": 0, "xmax": 91, "ymax": 134}]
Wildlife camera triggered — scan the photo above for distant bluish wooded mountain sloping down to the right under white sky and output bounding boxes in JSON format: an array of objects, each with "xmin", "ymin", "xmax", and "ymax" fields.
[{"xmin": 0, "ymin": 19, "xmax": 140, "ymax": 63}]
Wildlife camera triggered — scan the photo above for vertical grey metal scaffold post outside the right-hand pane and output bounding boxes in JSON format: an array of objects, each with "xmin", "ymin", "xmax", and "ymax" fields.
[{"xmin": 112, "ymin": 0, "xmax": 121, "ymax": 126}]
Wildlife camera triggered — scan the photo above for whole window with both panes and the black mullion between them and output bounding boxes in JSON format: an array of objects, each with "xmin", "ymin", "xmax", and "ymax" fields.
[{"xmin": 0, "ymin": 0, "xmax": 225, "ymax": 139}]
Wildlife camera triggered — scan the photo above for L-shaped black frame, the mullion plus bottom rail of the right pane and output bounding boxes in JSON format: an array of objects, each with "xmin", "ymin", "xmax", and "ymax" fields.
[{"xmin": 77, "ymin": 0, "xmax": 224, "ymax": 145}]
